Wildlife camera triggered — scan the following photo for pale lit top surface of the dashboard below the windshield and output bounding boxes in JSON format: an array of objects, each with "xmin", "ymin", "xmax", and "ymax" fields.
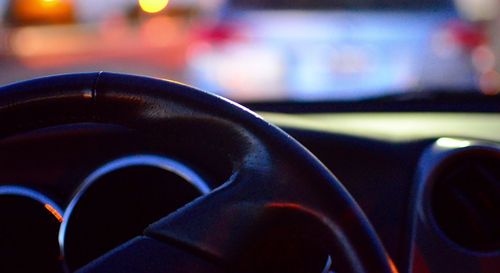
[{"xmin": 259, "ymin": 112, "xmax": 500, "ymax": 142}]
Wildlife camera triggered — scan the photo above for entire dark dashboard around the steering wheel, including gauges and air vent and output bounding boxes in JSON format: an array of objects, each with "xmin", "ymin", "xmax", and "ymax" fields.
[{"xmin": 0, "ymin": 73, "xmax": 500, "ymax": 273}]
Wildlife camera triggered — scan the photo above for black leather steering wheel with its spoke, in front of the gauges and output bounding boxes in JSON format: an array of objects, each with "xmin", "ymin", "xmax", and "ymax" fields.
[{"xmin": 0, "ymin": 72, "xmax": 396, "ymax": 273}]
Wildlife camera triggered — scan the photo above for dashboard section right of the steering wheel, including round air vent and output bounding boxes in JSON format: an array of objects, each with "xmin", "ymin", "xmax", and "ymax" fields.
[{"xmin": 263, "ymin": 112, "xmax": 500, "ymax": 272}]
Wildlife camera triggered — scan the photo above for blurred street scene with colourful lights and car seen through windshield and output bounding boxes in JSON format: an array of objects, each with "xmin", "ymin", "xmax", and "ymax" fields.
[{"xmin": 0, "ymin": 0, "xmax": 500, "ymax": 101}]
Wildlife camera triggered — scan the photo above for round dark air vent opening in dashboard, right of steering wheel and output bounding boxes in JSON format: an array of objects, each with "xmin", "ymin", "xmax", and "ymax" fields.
[{"xmin": 431, "ymin": 151, "xmax": 500, "ymax": 252}]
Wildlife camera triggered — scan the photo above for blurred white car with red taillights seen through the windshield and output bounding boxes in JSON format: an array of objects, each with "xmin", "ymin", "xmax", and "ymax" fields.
[{"xmin": 187, "ymin": 0, "xmax": 476, "ymax": 100}]
